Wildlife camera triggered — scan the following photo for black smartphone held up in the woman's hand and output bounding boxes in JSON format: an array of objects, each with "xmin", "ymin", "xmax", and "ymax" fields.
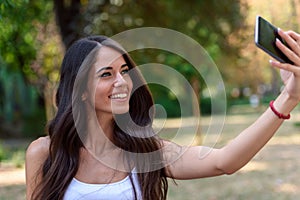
[{"xmin": 255, "ymin": 16, "xmax": 293, "ymax": 64}]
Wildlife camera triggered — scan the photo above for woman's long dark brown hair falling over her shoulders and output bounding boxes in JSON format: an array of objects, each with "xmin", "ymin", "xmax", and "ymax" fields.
[{"xmin": 32, "ymin": 36, "xmax": 168, "ymax": 200}]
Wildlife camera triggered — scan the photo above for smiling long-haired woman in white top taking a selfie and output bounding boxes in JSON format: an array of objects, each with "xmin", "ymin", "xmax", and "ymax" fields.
[{"xmin": 26, "ymin": 31, "xmax": 300, "ymax": 200}]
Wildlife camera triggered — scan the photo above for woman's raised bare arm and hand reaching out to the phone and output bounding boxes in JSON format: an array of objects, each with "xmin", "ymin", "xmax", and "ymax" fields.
[{"xmin": 165, "ymin": 30, "xmax": 300, "ymax": 179}]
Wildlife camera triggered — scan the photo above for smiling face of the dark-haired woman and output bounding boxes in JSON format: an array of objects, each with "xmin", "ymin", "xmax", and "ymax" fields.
[{"xmin": 89, "ymin": 46, "xmax": 132, "ymax": 116}]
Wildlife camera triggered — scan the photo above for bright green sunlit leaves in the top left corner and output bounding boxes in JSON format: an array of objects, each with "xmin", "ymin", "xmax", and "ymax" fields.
[{"xmin": 0, "ymin": 0, "xmax": 51, "ymax": 75}]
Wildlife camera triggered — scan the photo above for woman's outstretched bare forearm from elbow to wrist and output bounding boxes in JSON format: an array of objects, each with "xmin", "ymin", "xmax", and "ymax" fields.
[{"xmin": 218, "ymin": 91, "xmax": 297, "ymax": 174}]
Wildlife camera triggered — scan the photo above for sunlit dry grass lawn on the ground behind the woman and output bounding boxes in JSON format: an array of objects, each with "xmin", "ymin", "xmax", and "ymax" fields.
[{"xmin": 0, "ymin": 105, "xmax": 300, "ymax": 200}]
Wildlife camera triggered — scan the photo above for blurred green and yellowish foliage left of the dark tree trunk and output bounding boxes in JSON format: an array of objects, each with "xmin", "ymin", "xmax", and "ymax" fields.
[{"xmin": 0, "ymin": 0, "xmax": 60, "ymax": 137}]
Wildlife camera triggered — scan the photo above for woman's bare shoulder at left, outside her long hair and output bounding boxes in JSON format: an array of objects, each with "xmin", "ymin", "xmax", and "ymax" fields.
[{"xmin": 26, "ymin": 136, "xmax": 50, "ymax": 160}]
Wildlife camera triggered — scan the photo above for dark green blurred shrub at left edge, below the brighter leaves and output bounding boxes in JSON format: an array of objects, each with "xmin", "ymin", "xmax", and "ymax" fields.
[{"xmin": 0, "ymin": 67, "xmax": 45, "ymax": 137}]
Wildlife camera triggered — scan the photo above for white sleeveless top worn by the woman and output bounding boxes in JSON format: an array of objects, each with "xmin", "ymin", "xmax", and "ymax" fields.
[{"xmin": 64, "ymin": 173, "xmax": 142, "ymax": 200}]
